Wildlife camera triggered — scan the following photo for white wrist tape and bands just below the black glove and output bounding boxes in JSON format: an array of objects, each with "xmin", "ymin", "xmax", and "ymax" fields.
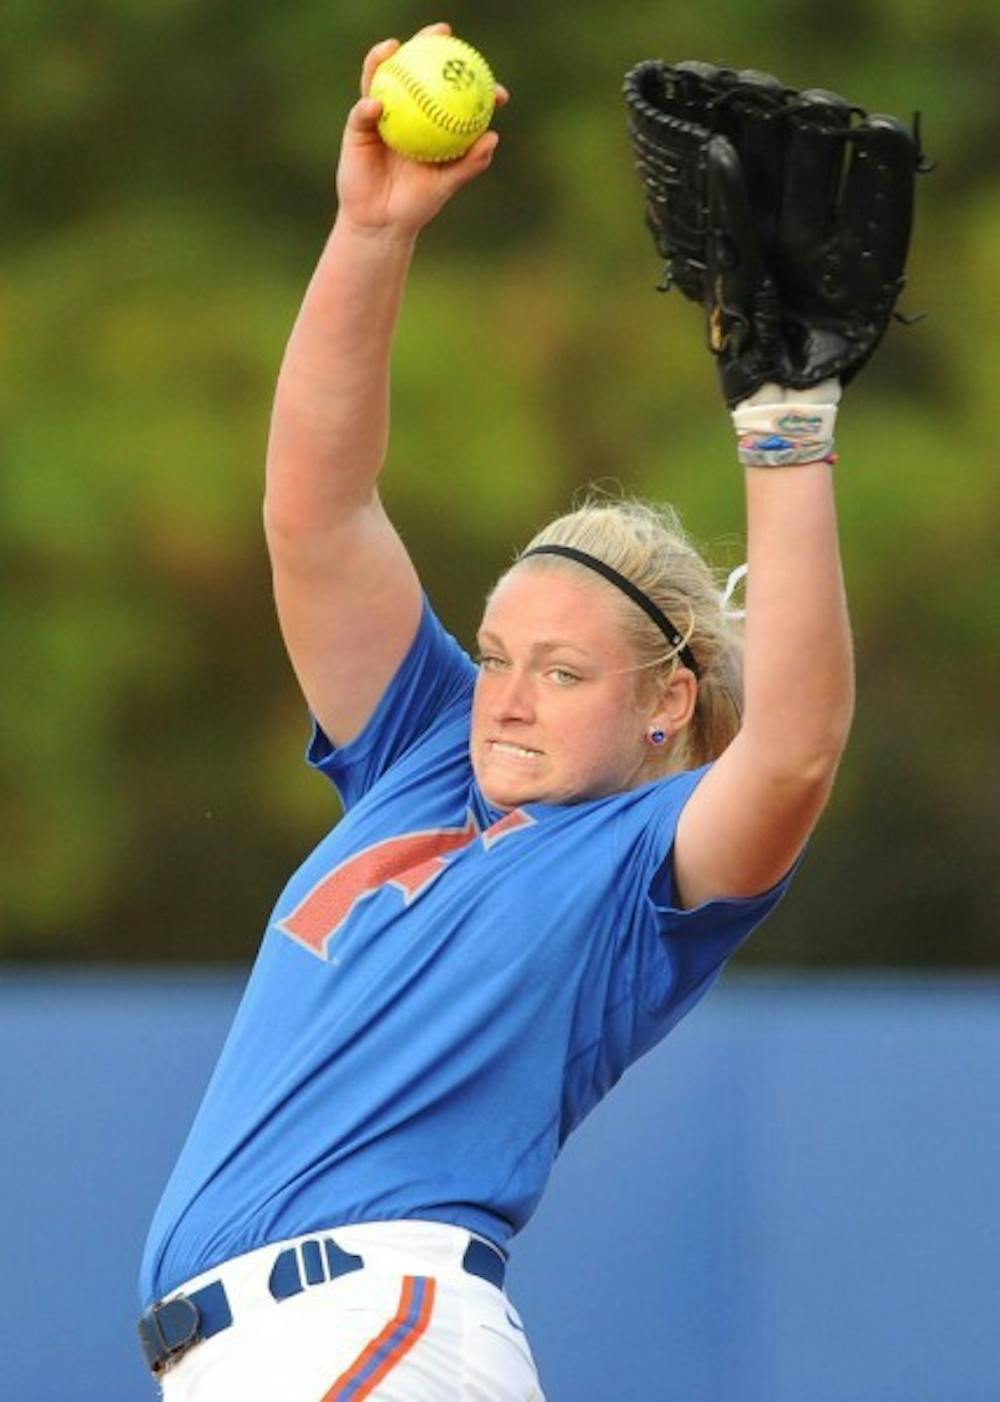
[{"xmin": 732, "ymin": 380, "xmax": 840, "ymax": 467}]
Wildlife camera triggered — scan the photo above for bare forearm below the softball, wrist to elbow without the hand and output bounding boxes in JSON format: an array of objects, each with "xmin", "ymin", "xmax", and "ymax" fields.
[{"xmin": 265, "ymin": 219, "xmax": 415, "ymax": 534}]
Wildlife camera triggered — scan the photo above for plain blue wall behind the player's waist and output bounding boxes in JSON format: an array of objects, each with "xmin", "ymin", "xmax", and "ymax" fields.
[{"xmin": 0, "ymin": 972, "xmax": 1000, "ymax": 1402}]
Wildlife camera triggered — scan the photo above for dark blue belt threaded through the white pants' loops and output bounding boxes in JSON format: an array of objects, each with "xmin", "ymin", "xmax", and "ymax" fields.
[{"xmin": 139, "ymin": 1237, "xmax": 506, "ymax": 1374}]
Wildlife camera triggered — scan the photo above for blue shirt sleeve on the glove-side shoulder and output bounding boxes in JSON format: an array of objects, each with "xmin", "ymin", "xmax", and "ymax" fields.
[{"xmin": 611, "ymin": 765, "xmax": 801, "ymax": 1056}]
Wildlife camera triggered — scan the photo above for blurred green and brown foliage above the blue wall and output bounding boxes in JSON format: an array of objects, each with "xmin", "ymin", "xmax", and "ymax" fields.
[{"xmin": 0, "ymin": 0, "xmax": 1000, "ymax": 966}]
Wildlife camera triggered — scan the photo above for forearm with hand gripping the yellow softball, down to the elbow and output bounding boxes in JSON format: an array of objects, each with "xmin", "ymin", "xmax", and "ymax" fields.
[{"xmin": 265, "ymin": 32, "xmax": 508, "ymax": 543}]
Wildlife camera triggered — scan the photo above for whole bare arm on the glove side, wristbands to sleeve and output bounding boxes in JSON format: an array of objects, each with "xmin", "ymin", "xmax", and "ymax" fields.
[{"xmin": 673, "ymin": 445, "xmax": 854, "ymax": 907}]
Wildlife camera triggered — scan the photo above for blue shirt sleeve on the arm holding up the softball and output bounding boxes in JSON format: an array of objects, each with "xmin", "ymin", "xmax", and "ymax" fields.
[{"xmin": 306, "ymin": 596, "xmax": 475, "ymax": 809}]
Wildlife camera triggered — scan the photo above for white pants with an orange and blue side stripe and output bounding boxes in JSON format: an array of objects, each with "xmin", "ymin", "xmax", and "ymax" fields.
[{"xmin": 155, "ymin": 1221, "xmax": 544, "ymax": 1402}]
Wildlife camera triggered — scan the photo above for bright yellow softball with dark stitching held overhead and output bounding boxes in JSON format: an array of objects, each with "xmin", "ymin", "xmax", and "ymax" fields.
[{"xmin": 372, "ymin": 34, "xmax": 495, "ymax": 161}]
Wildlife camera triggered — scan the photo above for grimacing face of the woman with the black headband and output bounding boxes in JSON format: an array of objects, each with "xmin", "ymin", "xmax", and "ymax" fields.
[{"xmin": 471, "ymin": 565, "xmax": 652, "ymax": 809}]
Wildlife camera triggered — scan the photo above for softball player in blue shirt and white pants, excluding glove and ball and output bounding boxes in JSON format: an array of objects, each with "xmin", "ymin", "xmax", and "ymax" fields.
[{"xmin": 140, "ymin": 27, "xmax": 851, "ymax": 1402}]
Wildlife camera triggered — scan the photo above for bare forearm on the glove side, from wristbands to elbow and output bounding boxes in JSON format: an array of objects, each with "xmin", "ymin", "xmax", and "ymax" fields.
[{"xmin": 743, "ymin": 463, "xmax": 854, "ymax": 782}]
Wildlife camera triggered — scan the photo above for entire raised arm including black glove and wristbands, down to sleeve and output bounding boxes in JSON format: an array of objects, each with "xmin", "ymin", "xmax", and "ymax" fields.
[{"xmin": 624, "ymin": 59, "xmax": 931, "ymax": 906}]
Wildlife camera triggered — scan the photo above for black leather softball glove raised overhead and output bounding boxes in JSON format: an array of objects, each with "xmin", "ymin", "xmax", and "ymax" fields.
[{"xmin": 624, "ymin": 59, "xmax": 928, "ymax": 407}]
